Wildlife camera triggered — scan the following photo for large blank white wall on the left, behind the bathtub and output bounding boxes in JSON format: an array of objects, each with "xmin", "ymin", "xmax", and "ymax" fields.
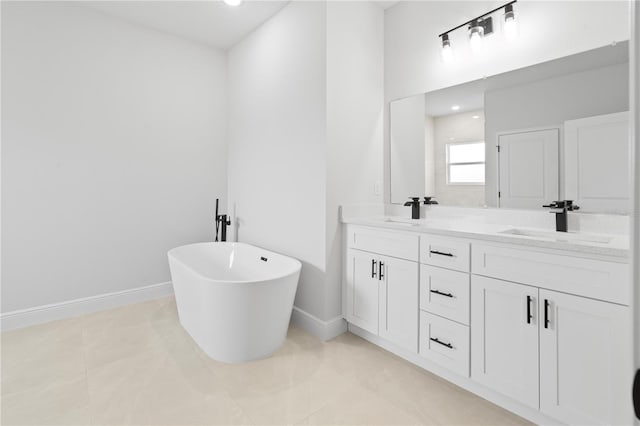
[{"xmin": 2, "ymin": 2, "xmax": 226, "ymax": 312}]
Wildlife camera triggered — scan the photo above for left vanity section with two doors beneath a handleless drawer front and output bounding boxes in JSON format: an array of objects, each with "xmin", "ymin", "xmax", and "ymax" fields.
[{"xmin": 344, "ymin": 227, "xmax": 419, "ymax": 353}]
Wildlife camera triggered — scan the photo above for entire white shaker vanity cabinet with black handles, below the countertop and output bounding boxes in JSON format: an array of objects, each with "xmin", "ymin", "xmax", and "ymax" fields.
[{"xmin": 343, "ymin": 225, "xmax": 633, "ymax": 425}]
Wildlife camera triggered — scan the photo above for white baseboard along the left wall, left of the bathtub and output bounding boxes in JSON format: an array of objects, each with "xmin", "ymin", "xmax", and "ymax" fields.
[{"xmin": 0, "ymin": 281, "xmax": 173, "ymax": 330}]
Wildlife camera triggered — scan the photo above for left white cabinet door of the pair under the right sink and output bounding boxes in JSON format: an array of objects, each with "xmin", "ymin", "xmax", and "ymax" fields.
[{"xmin": 471, "ymin": 276, "xmax": 538, "ymax": 409}]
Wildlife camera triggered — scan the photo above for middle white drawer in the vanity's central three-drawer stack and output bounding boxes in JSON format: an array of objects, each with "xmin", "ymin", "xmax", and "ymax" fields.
[{"xmin": 420, "ymin": 265, "xmax": 469, "ymax": 325}]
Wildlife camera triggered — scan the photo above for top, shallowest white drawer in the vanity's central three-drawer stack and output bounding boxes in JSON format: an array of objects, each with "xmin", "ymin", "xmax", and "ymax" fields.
[{"xmin": 420, "ymin": 235, "xmax": 470, "ymax": 272}]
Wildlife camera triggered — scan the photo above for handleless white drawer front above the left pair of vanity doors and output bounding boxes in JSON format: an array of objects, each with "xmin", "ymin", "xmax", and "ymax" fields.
[{"xmin": 347, "ymin": 226, "xmax": 419, "ymax": 262}]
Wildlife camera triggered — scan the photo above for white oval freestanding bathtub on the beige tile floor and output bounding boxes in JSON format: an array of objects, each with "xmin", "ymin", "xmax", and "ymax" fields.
[{"xmin": 168, "ymin": 242, "xmax": 302, "ymax": 363}]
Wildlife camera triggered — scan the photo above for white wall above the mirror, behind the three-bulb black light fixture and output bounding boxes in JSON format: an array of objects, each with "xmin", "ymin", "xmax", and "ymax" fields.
[{"xmin": 384, "ymin": 0, "xmax": 629, "ymax": 203}]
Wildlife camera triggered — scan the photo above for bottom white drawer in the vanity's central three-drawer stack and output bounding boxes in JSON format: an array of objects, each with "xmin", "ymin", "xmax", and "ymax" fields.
[{"xmin": 420, "ymin": 312, "xmax": 469, "ymax": 377}]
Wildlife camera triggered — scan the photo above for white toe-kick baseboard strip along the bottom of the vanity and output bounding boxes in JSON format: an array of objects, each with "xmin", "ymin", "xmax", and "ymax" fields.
[{"xmin": 348, "ymin": 323, "xmax": 559, "ymax": 425}]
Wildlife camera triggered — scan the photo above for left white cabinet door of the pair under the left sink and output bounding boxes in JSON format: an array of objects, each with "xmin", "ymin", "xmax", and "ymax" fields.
[{"xmin": 346, "ymin": 249, "xmax": 379, "ymax": 334}]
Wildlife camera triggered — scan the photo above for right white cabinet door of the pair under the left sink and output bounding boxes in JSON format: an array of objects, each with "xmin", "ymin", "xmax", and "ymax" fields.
[{"xmin": 379, "ymin": 256, "xmax": 420, "ymax": 353}]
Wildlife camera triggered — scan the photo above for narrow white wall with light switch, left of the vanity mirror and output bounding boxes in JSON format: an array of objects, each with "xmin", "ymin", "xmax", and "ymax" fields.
[{"xmin": 324, "ymin": 1, "xmax": 384, "ymax": 319}]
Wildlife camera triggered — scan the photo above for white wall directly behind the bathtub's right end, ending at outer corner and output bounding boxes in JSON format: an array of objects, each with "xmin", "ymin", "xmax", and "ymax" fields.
[{"xmin": 228, "ymin": 2, "xmax": 327, "ymax": 317}]
